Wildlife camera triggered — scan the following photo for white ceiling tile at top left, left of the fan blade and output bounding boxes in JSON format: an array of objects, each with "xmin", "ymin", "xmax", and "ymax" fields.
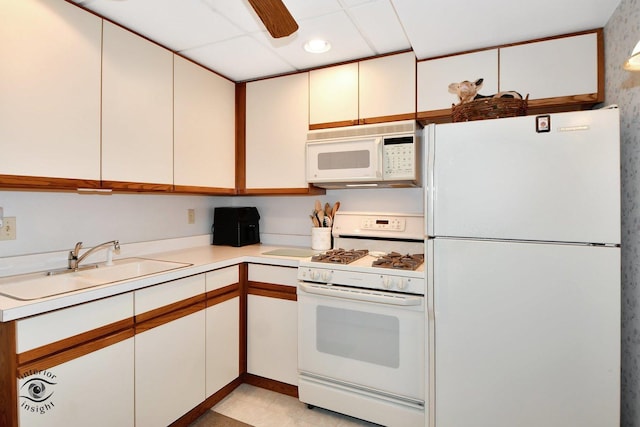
[{"xmin": 76, "ymin": 0, "xmax": 241, "ymax": 50}]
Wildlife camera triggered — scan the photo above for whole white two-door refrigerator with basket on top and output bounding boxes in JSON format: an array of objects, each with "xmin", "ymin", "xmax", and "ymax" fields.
[{"xmin": 425, "ymin": 109, "xmax": 620, "ymax": 427}]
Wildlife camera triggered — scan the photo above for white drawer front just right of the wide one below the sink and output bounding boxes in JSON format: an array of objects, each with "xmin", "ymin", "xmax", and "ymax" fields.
[{"xmin": 134, "ymin": 274, "xmax": 205, "ymax": 316}]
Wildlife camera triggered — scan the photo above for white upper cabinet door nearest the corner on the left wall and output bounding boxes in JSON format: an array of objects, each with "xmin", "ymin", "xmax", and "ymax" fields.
[{"xmin": 174, "ymin": 56, "xmax": 235, "ymax": 189}]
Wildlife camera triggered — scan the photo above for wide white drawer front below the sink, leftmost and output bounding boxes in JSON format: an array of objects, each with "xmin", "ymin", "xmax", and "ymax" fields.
[{"xmin": 16, "ymin": 293, "xmax": 133, "ymax": 353}]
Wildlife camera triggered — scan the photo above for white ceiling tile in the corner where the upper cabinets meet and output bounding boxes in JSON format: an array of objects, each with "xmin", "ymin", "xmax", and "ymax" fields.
[{"xmin": 181, "ymin": 36, "xmax": 295, "ymax": 82}]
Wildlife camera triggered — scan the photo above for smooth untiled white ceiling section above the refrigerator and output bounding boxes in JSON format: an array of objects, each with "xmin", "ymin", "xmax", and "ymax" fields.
[{"xmin": 391, "ymin": 0, "xmax": 620, "ymax": 59}]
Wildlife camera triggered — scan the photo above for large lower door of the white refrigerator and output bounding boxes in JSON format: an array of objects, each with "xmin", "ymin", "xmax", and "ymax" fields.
[{"xmin": 430, "ymin": 238, "xmax": 620, "ymax": 427}]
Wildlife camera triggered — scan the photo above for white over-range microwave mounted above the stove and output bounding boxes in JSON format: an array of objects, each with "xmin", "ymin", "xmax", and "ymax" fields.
[{"xmin": 306, "ymin": 120, "xmax": 423, "ymax": 189}]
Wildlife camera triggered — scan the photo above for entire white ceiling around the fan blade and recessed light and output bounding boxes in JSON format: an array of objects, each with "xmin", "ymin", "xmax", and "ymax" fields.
[{"xmin": 71, "ymin": 0, "xmax": 620, "ymax": 82}]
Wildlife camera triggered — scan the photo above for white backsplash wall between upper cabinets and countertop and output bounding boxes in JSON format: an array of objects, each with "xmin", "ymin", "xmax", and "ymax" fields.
[{"xmin": 0, "ymin": 188, "xmax": 424, "ymax": 263}]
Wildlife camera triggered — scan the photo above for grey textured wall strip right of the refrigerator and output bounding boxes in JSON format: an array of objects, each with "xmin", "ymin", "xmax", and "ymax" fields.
[{"xmin": 604, "ymin": 0, "xmax": 640, "ymax": 427}]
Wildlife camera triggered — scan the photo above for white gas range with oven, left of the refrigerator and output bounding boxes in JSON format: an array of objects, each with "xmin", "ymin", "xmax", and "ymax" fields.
[{"xmin": 298, "ymin": 212, "xmax": 427, "ymax": 426}]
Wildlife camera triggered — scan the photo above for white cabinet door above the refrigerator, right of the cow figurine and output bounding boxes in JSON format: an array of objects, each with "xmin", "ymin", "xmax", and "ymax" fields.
[{"xmin": 500, "ymin": 33, "xmax": 598, "ymax": 99}]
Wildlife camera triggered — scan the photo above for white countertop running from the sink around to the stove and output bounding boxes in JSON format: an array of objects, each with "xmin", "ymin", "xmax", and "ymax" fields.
[{"xmin": 0, "ymin": 244, "xmax": 310, "ymax": 322}]
